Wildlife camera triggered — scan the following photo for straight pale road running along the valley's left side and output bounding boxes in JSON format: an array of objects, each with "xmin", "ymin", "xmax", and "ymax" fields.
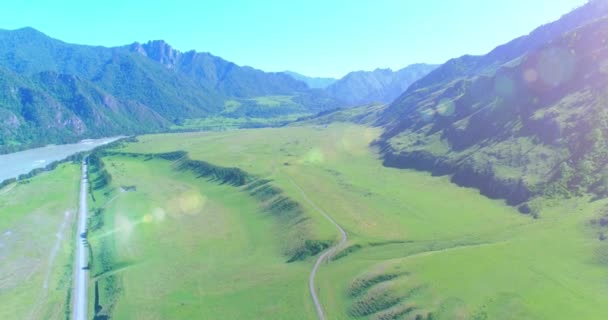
[{"xmin": 72, "ymin": 159, "xmax": 88, "ymax": 320}]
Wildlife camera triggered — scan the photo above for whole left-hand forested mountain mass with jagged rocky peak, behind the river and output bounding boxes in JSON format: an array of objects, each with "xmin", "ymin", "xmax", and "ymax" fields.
[{"xmin": 0, "ymin": 28, "xmax": 338, "ymax": 153}]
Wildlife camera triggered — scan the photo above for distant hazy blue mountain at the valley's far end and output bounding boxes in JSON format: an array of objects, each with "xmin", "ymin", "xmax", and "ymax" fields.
[{"xmin": 326, "ymin": 64, "xmax": 437, "ymax": 106}]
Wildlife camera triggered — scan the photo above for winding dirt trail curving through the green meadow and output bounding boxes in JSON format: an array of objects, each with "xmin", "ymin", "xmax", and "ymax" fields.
[{"xmin": 288, "ymin": 177, "xmax": 348, "ymax": 320}]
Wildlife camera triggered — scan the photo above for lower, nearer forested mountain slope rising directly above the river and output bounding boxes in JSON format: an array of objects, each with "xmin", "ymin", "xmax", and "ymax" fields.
[{"xmin": 0, "ymin": 68, "xmax": 169, "ymax": 152}]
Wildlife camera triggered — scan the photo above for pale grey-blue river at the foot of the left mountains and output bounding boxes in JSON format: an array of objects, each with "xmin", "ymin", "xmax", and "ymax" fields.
[{"xmin": 0, "ymin": 137, "xmax": 121, "ymax": 182}]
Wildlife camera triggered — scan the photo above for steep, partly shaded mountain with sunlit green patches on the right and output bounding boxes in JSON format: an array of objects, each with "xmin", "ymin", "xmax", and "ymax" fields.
[{"xmin": 377, "ymin": 0, "xmax": 608, "ymax": 212}]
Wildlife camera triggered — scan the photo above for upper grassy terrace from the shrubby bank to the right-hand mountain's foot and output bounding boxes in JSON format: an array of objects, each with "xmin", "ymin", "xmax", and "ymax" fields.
[{"xmin": 107, "ymin": 125, "xmax": 608, "ymax": 319}]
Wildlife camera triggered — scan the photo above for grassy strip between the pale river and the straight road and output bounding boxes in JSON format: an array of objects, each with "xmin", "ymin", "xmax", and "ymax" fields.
[{"xmin": 0, "ymin": 164, "xmax": 80, "ymax": 319}]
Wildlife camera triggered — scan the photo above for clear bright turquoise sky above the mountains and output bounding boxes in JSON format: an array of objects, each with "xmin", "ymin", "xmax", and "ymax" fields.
[{"xmin": 0, "ymin": 0, "xmax": 586, "ymax": 77}]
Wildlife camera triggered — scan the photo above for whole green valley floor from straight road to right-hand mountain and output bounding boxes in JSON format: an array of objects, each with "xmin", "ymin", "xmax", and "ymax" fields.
[{"xmin": 0, "ymin": 124, "xmax": 608, "ymax": 319}]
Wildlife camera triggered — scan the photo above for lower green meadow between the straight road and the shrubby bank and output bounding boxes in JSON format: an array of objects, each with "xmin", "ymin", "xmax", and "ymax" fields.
[{"xmin": 89, "ymin": 156, "xmax": 326, "ymax": 319}]
